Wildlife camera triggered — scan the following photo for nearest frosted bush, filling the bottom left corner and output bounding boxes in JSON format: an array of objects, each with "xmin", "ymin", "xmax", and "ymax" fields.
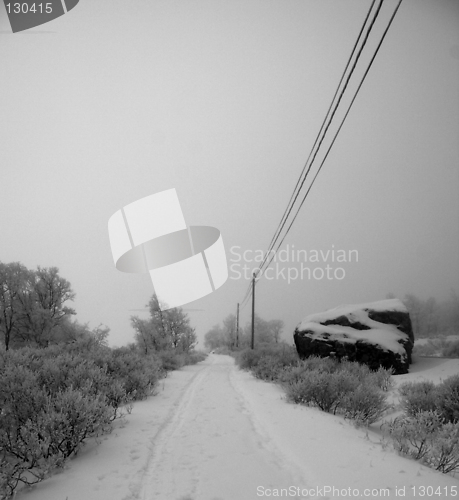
[{"xmin": 0, "ymin": 364, "xmax": 113, "ymax": 496}]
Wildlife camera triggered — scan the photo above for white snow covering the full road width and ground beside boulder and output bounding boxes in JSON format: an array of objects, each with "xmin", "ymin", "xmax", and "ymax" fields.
[{"xmin": 16, "ymin": 354, "xmax": 459, "ymax": 500}]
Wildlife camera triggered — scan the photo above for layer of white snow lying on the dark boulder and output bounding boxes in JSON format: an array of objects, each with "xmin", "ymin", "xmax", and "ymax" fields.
[{"xmin": 297, "ymin": 299, "xmax": 408, "ymax": 355}]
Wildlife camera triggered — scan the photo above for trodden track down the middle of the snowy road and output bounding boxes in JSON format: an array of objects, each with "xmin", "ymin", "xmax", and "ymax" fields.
[{"xmin": 140, "ymin": 356, "xmax": 310, "ymax": 500}]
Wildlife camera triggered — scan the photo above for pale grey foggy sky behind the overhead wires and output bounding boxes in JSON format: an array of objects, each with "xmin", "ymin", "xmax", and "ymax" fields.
[{"xmin": 0, "ymin": 0, "xmax": 459, "ymax": 345}]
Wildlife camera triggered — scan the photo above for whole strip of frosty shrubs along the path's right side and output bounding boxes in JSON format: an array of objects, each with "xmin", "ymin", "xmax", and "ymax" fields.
[{"xmin": 219, "ymin": 334, "xmax": 459, "ymax": 473}]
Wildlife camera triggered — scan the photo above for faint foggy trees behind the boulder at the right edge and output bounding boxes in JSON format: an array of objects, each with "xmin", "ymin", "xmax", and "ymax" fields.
[{"xmin": 387, "ymin": 290, "xmax": 459, "ymax": 338}]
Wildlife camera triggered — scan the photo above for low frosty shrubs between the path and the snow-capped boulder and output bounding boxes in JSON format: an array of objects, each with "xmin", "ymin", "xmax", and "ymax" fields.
[{"xmin": 236, "ymin": 345, "xmax": 392, "ymax": 426}]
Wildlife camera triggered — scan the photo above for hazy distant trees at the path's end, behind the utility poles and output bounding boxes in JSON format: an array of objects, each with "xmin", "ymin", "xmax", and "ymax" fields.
[{"xmin": 204, "ymin": 314, "xmax": 284, "ymax": 351}]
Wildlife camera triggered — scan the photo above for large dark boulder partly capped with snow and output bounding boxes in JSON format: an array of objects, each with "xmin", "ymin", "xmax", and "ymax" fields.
[{"xmin": 293, "ymin": 299, "xmax": 414, "ymax": 374}]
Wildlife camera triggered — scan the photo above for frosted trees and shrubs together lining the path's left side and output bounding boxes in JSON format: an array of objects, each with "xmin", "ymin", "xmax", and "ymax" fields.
[{"xmin": 0, "ymin": 263, "xmax": 206, "ymax": 499}]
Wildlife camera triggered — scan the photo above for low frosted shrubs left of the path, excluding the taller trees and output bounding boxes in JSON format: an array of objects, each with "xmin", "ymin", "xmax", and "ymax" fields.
[{"xmin": 0, "ymin": 343, "xmax": 166, "ymax": 496}]
